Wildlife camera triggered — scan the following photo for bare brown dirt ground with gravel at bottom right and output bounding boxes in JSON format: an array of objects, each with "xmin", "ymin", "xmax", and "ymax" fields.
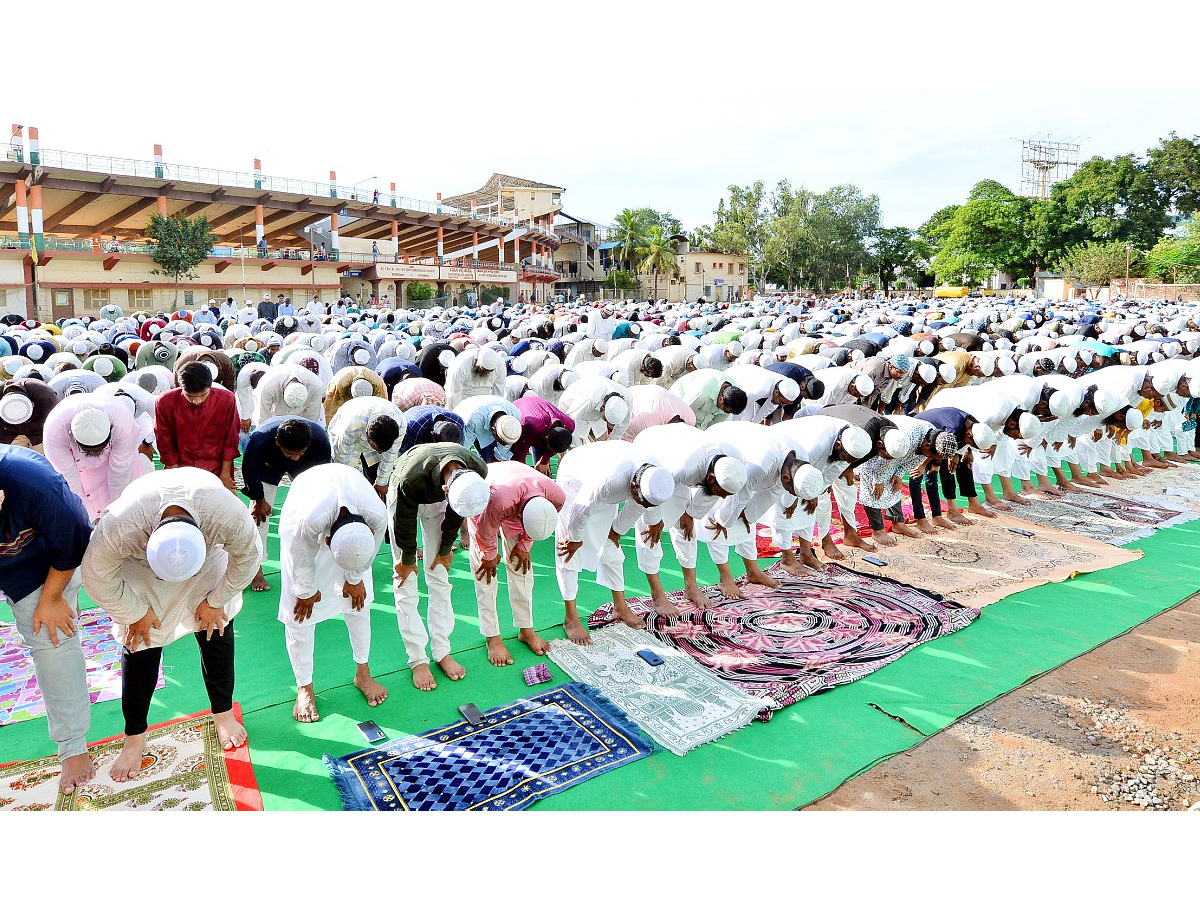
[{"xmin": 804, "ymin": 594, "xmax": 1200, "ymax": 811}]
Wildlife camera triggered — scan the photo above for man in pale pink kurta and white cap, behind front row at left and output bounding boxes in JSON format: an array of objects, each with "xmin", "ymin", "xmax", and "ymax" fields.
[{"xmin": 43, "ymin": 394, "xmax": 143, "ymax": 522}]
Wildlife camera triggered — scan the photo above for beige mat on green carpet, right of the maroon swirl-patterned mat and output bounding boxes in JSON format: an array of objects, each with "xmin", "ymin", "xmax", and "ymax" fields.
[{"xmin": 841, "ymin": 514, "xmax": 1142, "ymax": 610}]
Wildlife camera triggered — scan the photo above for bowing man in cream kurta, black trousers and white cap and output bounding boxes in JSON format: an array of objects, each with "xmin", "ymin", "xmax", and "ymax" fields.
[{"xmin": 83, "ymin": 467, "xmax": 263, "ymax": 781}]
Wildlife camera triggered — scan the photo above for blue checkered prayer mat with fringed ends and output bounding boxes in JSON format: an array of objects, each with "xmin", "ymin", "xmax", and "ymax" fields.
[{"xmin": 324, "ymin": 682, "xmax": 654, "ymax": 811}]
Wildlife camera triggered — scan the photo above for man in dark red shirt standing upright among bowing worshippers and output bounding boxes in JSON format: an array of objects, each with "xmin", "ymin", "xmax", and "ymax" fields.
[{"xmin": 155, "ymin": 360, "xmax": 241, "ymax": 493}]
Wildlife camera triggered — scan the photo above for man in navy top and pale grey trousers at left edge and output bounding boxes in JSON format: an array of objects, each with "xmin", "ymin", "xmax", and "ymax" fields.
[{"xmin": 0, "ymin": 445, "xmax": 96, "ymax": 794}]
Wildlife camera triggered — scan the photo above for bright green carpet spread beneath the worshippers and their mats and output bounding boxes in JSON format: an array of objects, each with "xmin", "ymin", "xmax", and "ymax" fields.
[{"xmin": 0, "ymin": 465, "xmax": 1200, "ymax": 810}]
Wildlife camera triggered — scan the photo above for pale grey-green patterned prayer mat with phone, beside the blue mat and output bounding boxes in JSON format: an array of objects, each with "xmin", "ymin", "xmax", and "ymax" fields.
[{"xmin": 550, "ymin": 623, "xmax": 762, "ymax": 756}]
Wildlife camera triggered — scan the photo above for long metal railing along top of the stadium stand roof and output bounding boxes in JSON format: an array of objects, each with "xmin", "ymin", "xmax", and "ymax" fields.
[{"xmin": 32, "ymin": 150, "xmax": 514, "ymax": 226}]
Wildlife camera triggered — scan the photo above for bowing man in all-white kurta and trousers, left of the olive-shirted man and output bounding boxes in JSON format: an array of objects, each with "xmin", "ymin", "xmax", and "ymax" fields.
[{"xmin": 280, "ymin": 463, "xmax": 388, "ymax": 722}]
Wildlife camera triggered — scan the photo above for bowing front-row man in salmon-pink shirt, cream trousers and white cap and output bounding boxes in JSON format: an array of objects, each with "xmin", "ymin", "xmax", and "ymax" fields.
[{"xmin": 467, "ymin": 461, "xmax": 566, "ymax": 666}]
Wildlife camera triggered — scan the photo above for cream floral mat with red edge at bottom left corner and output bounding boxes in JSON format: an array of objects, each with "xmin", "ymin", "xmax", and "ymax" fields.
[{"xmin": 0, "ymin": 703, "xmax": 263, "ymax": 812}]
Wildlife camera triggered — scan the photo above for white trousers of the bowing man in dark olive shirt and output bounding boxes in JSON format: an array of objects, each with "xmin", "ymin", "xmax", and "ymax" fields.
[{"xmin": 388, "ymin": 501, "xmax": 454, "ymax": 667}]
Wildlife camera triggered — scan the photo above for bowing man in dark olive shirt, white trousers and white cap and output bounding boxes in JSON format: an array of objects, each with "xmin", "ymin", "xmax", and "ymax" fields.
[{"xmin": 388, "ymin": 442, "xmax": 490, "ymax": 691}]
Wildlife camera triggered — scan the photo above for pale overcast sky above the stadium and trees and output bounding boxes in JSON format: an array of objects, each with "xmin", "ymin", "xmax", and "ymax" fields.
[{"xmin": 11, "ymin": 0, "xmax": 1200, "ymax": 234}]
